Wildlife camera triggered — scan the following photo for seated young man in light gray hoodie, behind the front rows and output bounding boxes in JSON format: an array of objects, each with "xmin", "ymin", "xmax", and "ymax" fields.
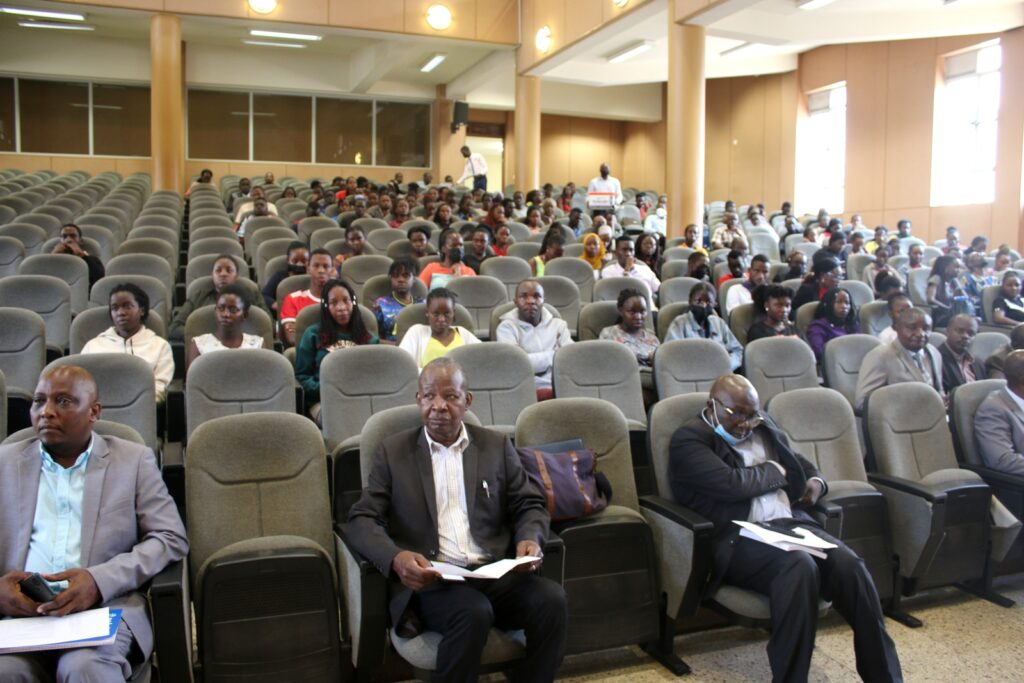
[{"xmin": 495, "ymin": 280, "xmax": 572, "ymax": 400}]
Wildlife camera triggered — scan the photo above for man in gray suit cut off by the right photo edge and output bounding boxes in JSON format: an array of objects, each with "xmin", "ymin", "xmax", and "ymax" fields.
[{"xmin": 974, "ymin": 351, "xmax": 1024, "ymax": 476}]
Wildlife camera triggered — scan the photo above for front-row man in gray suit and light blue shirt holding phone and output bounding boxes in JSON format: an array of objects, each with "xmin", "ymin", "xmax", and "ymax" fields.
[{"xmin": 0, "ymin": 367, "xmax": 188, "ymax": 683}]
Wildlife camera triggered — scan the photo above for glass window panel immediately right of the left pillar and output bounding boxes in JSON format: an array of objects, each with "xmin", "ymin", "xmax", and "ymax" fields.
[{"xmin": 188, "ymin": 90, "xmax": 249, "ymax": 160}]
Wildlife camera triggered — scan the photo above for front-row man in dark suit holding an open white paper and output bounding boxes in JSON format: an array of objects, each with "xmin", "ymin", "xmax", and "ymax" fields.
[{"xmin": 347, "ymin": 357, "xmax": 567, "ymax": 683}]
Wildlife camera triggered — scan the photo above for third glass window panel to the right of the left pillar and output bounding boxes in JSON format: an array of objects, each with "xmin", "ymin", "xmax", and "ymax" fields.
[{"xmin": 316, "ymin": 97, "xmax": 374, "ymax": 165}]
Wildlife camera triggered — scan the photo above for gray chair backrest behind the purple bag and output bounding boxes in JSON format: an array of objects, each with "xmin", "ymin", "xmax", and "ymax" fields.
[{"xmin": 515, "ymin": 397, "xmax": 638, "ymax": 510}]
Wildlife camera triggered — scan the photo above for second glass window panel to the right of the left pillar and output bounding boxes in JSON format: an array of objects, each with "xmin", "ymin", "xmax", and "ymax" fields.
[{"xmin": 253, "ymin": 95, "xmax": 312, "ymax": 163}]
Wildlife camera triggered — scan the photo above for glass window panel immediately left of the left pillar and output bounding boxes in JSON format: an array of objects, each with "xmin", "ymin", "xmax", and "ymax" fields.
[{"xmin": 92, "ymin": 84, "xmax": 150, "ymax": 157}]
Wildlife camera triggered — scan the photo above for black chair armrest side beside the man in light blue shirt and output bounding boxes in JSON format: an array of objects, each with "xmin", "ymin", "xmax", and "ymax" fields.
[{"xmin": 150, "ymin": 560, "xmax": 194, "ymax": 682}]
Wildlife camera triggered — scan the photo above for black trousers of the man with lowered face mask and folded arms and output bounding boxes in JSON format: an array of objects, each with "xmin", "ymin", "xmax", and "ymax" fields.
[{"xmin": 724, "ymin": 524, "xmax": 903, "ymax": 683}]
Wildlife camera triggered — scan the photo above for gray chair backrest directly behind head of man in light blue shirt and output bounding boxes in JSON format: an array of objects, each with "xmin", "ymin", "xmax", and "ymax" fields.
[{"xmin": 47, "ymin": 353, "xmax": 158, "ymax": 452}]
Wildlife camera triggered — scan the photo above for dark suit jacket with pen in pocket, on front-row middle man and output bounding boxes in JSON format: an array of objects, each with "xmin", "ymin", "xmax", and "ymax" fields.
[{"xmin": 346, "ymin": 425, "xmax": 550, "ymax": 625}]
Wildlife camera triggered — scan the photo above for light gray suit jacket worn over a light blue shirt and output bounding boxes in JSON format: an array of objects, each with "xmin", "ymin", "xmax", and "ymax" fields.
[{"xmin": 0, "ymin": 433, "xmax": 188, "ymax": 657}]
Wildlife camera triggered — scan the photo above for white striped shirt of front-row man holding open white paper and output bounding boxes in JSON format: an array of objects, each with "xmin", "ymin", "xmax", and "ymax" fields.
[{"xmin": 423, "ymin": 424, "xmax": 488, "ymax": 566}]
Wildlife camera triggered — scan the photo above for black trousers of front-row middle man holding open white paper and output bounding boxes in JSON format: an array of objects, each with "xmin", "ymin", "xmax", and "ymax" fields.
[{"xmin": 411, "ymin": 571, "xmax": 568, "ymax": 683}]
